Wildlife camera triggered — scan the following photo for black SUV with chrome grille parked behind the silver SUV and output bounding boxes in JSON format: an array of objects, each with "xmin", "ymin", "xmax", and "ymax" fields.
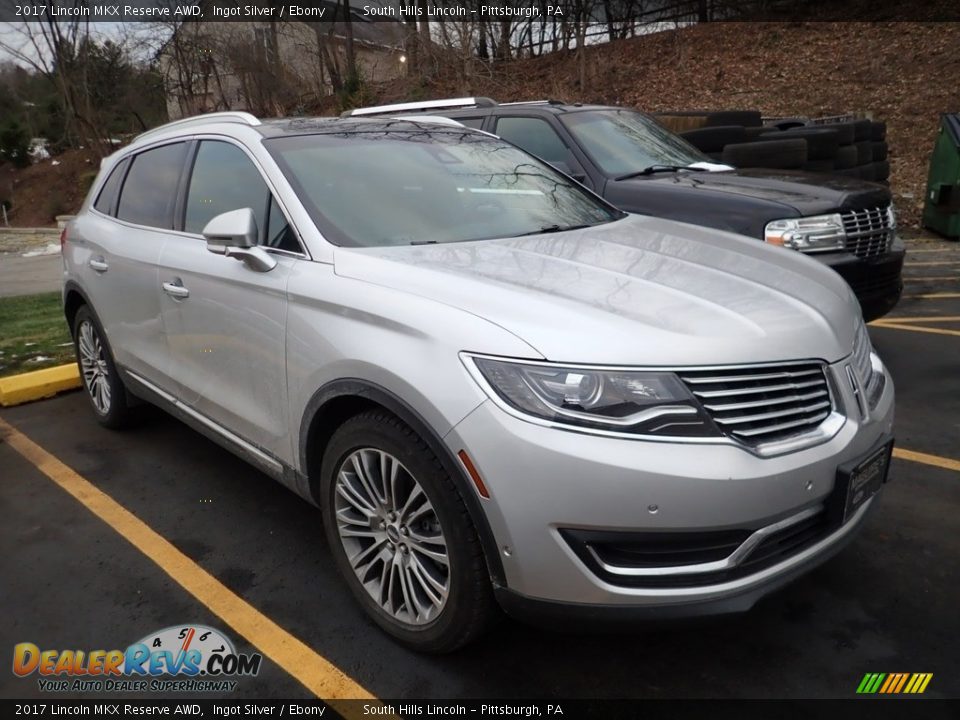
[{"xmin": 345, "ymin": 98, "xmax": 905, "ymax": 321}]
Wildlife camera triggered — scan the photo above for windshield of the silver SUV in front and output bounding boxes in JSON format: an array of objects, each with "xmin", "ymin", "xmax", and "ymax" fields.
[{"xmin": 265, "ymin": 128, "xmax": 623, "ymax": 247}]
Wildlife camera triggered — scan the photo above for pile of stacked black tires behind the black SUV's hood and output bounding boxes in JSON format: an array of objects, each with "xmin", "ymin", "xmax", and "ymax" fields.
[{"xmin": 679, "ymin": 112, "xmax": 890, "ymax": 183}]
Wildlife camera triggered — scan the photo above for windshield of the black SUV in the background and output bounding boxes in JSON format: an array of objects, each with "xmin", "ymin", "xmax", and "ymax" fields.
[{"xmin": 560, "ymin": 110, "xmax": 711, "ymax": 177}]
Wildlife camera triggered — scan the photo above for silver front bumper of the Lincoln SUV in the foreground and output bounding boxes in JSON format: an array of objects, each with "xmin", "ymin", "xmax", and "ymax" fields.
[{"xmin": 446, "ymin": 363, "xmax": 893, "ymax": 618}]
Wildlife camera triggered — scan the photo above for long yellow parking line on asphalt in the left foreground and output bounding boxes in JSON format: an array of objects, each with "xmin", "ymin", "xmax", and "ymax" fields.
[{"xmin": 0, "ymin": 420, "xmax": 386, "ymax": 701}]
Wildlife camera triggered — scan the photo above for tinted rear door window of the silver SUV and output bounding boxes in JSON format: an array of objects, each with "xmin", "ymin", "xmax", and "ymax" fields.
[{"xmin": 117, "ymin": 143, "xmax": 187, "ymax": 228}]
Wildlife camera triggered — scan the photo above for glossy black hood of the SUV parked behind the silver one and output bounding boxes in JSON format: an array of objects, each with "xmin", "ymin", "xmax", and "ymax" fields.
[{"xmin": 612, "ymin": 169, "xmax": 890, "ymax": 217}]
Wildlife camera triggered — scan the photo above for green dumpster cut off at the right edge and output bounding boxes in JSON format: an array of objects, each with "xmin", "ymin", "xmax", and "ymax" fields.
[{"xmin": 923, "ymin": 113, "xmax": 960, "ymax": 238}]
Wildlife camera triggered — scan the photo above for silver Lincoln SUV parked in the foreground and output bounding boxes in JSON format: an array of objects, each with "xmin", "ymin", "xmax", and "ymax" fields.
[{"xmin": 63, "ymin": 113, "xmax": 893, "ymax": 652}]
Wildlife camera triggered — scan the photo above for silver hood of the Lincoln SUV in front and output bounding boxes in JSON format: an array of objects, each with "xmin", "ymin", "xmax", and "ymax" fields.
[{"xmin": 334, "ymin": 216, "xmax": 859, "ymax": 366}]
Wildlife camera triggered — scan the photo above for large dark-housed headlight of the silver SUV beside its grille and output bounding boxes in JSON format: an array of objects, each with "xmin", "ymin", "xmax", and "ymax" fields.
[{"xmin": 465, "ymin": 355, "xmax": 720, "ymax": 437}]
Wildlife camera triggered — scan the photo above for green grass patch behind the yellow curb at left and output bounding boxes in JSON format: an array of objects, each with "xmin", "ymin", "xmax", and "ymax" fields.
[{"xmin": 0, "ymin": 292, "xmax": 74, "ymax": 377}]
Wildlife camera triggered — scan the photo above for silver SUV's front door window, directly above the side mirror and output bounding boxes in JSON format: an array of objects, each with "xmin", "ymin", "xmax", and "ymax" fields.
[{"xmin": 183, "ymin": 140, "xmax": 270, "ymax": 233}]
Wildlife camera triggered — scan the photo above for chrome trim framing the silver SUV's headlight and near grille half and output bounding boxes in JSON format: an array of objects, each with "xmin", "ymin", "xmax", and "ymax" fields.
[{"xmin": 459, "ymin": 350, "xmax": 847, "ymax": 458}]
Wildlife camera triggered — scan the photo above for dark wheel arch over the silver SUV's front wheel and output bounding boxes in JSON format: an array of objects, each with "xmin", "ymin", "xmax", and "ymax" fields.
[{"xmin": 298, "ymin": 378, "xmax": 506, "ymax": 587}]
